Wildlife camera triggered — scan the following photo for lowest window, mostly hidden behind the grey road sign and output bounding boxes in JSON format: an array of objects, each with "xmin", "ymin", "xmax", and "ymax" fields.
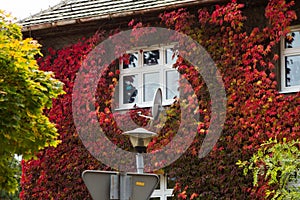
[{"xmin": 150, "ymin": 175, "xmax": 175, "ymax": 200}]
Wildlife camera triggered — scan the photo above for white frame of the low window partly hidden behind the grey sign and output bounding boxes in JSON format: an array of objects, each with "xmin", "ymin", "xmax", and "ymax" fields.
[{"xmin": 150, "ymin": 174, "xmax": 174, "ymax": 200}]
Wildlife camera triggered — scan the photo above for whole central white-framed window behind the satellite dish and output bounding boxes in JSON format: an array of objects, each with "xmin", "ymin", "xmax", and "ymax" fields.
[{"xmin": 117, "ymin": 46, "xmax": 179, "ymax": 109}]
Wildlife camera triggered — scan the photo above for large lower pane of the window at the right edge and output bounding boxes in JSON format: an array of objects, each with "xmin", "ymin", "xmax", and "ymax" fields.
[{"xmin": 285, "ymin": 56, "xmax": 300, "ymax": 87}]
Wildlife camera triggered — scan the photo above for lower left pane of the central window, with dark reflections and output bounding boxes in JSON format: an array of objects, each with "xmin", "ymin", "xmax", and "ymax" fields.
[{"xmin": 123, "ymin": 75, "xmax": 138, "ymax": 104}]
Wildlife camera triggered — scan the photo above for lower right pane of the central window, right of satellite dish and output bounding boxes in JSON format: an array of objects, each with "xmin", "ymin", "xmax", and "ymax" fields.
[{"xmin": 166, "ymin": 71, "xmax": 179, "ymax": 99}]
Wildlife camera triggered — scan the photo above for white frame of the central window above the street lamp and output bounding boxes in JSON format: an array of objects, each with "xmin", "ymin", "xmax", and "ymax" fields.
[{"xmin": 117, "ymin": 44, "xmax": 179, "ymax": 110}]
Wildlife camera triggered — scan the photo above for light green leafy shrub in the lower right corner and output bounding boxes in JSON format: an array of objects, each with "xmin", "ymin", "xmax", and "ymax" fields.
[{"xmin": 237, "ymin": 138, "xmax": 300, "ymax": 199}]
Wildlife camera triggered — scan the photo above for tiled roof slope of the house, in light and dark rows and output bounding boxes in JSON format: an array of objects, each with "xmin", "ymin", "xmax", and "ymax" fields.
[{"xmin": 20, "ymin": 0, "xmax": 213, "ymax": 27}]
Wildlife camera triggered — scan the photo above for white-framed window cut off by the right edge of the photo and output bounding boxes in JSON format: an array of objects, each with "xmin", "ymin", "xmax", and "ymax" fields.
[{"xmin": 281, "ymin": 27, "xmax": 300, "ymax": 93}]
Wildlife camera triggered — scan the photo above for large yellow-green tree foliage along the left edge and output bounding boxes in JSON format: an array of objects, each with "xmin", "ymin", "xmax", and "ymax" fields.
[{"xmin": 0, "ymin": 11, "xmax": 63, "ymax": 192}]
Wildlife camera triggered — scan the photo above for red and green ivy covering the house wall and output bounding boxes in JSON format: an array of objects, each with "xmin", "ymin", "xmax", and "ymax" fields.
[{"xmin": 20, "ymin": 0, "xmax": 300, "ymax": 199}]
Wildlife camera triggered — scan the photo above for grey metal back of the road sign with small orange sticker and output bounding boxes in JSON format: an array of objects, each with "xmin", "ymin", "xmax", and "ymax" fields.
[{"xmin": 82, "ymin": 170, "xmax": 159, "ymax": 200}]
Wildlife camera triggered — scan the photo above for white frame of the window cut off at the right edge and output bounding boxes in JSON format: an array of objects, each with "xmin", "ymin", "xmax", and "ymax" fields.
[{"xmin": 280, "ymin": 26, "xmax": 300, "ymax": 93}]
